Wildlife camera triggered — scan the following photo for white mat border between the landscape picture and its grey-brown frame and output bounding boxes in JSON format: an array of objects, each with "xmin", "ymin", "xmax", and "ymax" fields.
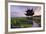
[{"xmin": 8, "ymin": 2, "xmax": 43, "ymax": 32}]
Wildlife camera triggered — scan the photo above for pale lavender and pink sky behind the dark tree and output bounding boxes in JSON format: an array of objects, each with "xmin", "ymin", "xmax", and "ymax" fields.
[{"xmin": 10, "ymin": 5, "xmax": 41, "ymax": 17}]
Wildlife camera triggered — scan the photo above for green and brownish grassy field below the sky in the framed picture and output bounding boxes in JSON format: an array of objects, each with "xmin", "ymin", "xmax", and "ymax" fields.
[{"xmin": 11, "ymin": 16, "xmax": 41, "ymax": 28}]
